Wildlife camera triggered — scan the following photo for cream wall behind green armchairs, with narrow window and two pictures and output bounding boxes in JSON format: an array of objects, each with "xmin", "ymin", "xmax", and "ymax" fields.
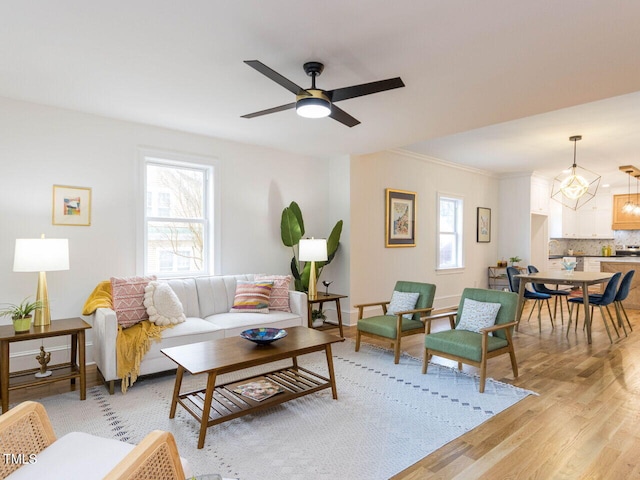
[{"xmin": 349, "ymin": 151, "xmax": 499, "ymax": 324}]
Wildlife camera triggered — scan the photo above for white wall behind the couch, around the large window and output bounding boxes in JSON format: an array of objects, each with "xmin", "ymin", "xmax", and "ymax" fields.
[{"xmin": 0, "ymin": 98, "xmax": 330, "ymax": 369}]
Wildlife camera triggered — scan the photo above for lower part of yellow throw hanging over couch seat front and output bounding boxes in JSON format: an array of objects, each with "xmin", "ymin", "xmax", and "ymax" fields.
[{"xmin": 116, "ymin": 320, "xmax": 173, "ymax": 393}]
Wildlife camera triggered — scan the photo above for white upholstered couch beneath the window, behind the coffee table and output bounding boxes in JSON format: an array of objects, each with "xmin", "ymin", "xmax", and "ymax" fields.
[{"xmin": 91, "ymin": 274, "xmax": 307, "ymax": 394}]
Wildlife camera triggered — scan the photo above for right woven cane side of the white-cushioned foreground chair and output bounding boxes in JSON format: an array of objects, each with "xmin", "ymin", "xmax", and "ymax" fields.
[{"xmin": 104, "ymin": 430, "xmax": 185, "ymax": 480}]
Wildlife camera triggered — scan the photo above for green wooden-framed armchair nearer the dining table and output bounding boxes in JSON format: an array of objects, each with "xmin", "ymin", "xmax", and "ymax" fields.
[{"xmin": 422, "ymin": 288, "xmax": 518, "ymax": 393}]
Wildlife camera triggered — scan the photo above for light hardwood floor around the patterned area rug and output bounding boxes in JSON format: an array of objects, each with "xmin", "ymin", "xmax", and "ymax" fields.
[{"xmin": 10, "ymin": 302, "xmax": 640, "ymax": 480}]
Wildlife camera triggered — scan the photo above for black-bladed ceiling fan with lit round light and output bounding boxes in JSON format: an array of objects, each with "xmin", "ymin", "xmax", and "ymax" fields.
[{"xmin": 242, "ymin": 60, "xmax": 404, "ymax": 127}]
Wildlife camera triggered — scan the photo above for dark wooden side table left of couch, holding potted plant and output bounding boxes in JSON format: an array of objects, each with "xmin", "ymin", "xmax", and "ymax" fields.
[{"xmin": 0, "ymin": 317, "xmax": 91, "ymax": 413}]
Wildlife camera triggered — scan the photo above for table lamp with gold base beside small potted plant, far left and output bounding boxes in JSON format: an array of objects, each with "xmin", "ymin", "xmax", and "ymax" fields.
[{"xmin": 13, "ymin": 234, "xmax": 69, "ymax": 327}]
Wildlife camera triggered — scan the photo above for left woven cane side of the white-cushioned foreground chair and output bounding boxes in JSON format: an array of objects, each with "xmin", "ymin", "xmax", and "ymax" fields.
[{"xmin": 0, "ymin": 401, "xmax": 56, "ymax": 478}]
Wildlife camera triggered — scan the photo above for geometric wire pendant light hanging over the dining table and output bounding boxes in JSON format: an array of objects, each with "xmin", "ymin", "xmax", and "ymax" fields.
[{"xmin": 551, "ymin": 135, "xmax": 600, "ymax": 210}]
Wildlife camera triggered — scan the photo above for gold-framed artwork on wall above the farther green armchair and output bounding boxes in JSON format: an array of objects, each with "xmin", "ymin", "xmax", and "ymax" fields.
[{"xmin": 385, "ymin": 188, "xmax": 416, "ymax": 247}]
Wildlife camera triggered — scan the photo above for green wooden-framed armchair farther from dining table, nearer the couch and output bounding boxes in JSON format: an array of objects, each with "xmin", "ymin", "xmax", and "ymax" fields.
[{"xmin": 354, "ymin": 281, "xmax": 436, "ymax": 363}]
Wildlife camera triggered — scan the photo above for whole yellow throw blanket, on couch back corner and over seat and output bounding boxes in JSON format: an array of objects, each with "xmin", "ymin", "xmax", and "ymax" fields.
[{"xmin": 82, "ymin": 280, "xmax": 173, "ymax": 393}]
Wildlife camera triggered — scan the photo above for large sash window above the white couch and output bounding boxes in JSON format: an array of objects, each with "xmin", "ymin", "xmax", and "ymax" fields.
[{"xmin": 144, "ymin": 156, "xmax": 213, "ymax": 276}]
